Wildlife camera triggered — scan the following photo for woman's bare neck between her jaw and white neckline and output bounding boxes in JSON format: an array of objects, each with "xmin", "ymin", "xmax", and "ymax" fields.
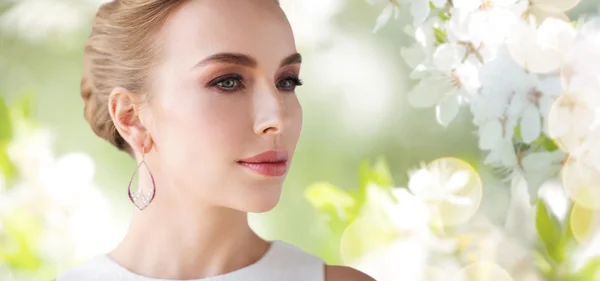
[{"xmin": 109, "ymin": 179, "xmax": 269, "ymax": 280}]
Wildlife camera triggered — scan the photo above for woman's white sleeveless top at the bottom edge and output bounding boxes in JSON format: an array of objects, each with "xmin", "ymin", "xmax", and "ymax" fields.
[{"xmin": 56, "ymin": 240, "xmax": 325, "ymax": 281}]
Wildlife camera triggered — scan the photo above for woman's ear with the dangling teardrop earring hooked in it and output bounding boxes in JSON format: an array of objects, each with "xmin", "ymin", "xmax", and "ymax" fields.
[{"xmin": 108, "ymin": 87, "xmax": 152, "ymax": 154}]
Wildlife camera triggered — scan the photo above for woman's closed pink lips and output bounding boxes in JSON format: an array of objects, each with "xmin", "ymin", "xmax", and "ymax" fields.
[{"xmin": 237, "ymin": 150, "xmax": 288, "ymax": 177}]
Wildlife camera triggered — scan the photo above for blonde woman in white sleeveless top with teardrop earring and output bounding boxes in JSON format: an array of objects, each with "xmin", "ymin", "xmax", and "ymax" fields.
[{"xmin": 56, "ymin": 0, "xmax": 373, "ymax": 281}]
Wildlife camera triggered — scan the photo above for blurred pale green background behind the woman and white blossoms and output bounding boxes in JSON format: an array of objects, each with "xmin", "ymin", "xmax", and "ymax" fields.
[{"xmin": 0, "ymin": 0, "xmax": 597, "ymax": 280}]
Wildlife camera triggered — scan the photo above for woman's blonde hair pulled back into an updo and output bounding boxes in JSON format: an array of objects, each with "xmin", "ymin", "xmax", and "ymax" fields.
[{"xmin": 80, "ymin": 0, "xmax": 185, "ymax": 154}]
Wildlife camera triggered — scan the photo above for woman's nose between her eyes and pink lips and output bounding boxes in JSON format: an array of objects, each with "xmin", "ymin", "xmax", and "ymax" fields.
[{"xmin": 253, "ymin": 82, "xmax": 286, "ymax": 136}]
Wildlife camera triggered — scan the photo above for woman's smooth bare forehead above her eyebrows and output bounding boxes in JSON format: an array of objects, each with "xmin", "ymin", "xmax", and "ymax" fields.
[{"xmin": 160, "ymin": 0, "xmax": 296, "ymax": 67}]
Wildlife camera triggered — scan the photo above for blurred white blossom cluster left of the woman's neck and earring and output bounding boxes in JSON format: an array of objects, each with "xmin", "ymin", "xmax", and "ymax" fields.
[{"xmin": 0, "ymin": 123, "xmax": 116, "ymax": 265}]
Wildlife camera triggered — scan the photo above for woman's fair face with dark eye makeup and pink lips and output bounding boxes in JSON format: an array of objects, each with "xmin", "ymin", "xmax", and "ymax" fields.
[{"xmin": 141, "ymin": 0, "xmax": 302, "ymax": 212}]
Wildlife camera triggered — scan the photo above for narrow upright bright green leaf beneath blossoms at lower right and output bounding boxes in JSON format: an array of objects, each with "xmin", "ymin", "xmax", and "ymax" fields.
[{"xmin": 535, "ymin": 199, "xmax": 565, "ymax": 263}]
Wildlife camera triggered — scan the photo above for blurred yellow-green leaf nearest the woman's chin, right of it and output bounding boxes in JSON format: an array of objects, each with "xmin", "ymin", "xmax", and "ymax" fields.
[{"xmin": 304, "ymin": 182, "xmax": 356, "ymax": 221}]
